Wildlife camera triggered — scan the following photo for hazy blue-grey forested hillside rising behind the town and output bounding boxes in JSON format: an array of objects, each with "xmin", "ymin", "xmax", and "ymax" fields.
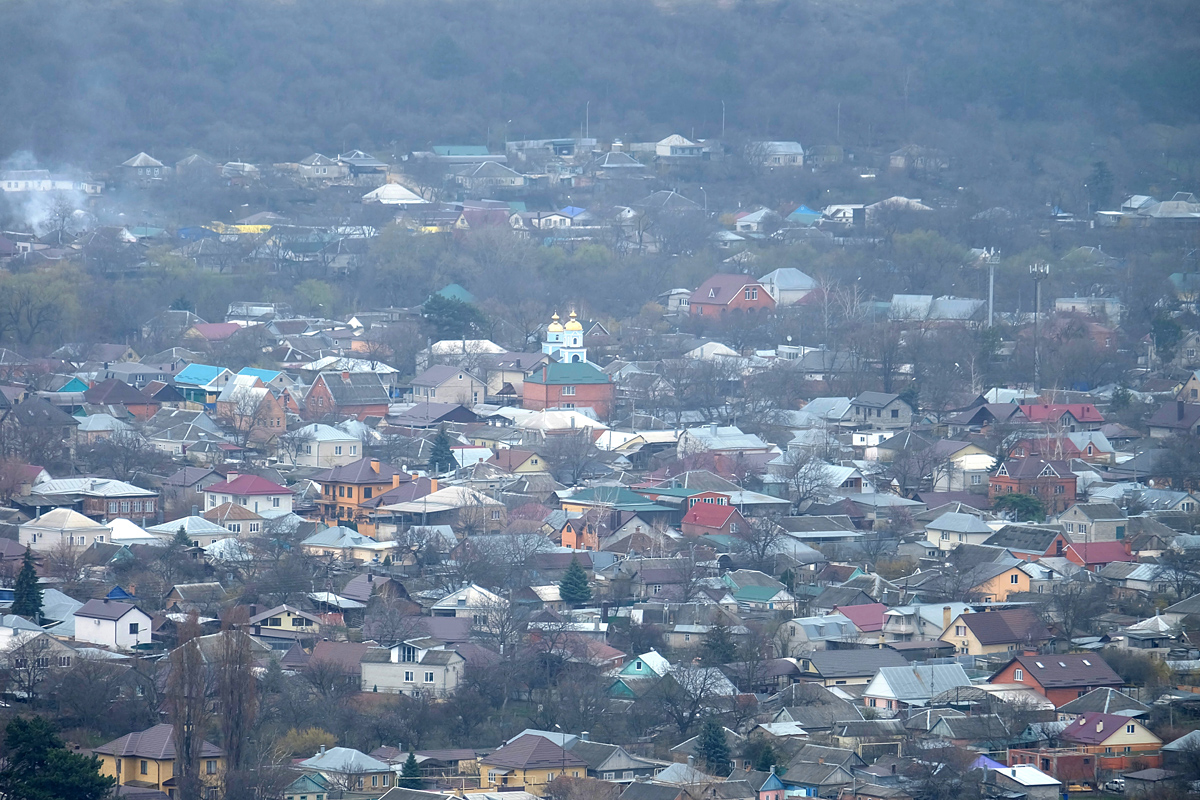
[{"xmin": 0, "ymin": 0, "xmax": 1200, "ymax": 169}]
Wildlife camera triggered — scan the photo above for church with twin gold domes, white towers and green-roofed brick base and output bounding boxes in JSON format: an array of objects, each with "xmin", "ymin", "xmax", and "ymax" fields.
[{"xmin": 521, "ymin": 311, "xmax": 616, "ymax": 419}]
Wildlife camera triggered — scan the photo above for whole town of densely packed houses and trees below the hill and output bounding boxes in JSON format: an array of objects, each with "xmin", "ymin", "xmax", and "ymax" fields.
[{"xmin": 0, "ymin": 128, "xmax": 1200, "ymax": 800}]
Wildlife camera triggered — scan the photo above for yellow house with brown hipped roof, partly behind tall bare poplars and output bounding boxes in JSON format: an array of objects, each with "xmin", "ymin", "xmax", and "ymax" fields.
[{"xmin": 91, "ymin": 724, "xmax": 226, "ymax": 798}]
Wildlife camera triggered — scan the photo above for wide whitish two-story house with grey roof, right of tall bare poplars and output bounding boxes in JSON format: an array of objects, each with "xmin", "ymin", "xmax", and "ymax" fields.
[{"xmin": 361, "ymin": 638, "xmax": 466, "ymax": 698}]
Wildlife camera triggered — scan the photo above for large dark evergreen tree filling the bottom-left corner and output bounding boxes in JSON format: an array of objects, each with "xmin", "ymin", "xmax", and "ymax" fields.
[{"xmin": 0, "ymin": 717, "xmax": 114, "ymax": 800}]
